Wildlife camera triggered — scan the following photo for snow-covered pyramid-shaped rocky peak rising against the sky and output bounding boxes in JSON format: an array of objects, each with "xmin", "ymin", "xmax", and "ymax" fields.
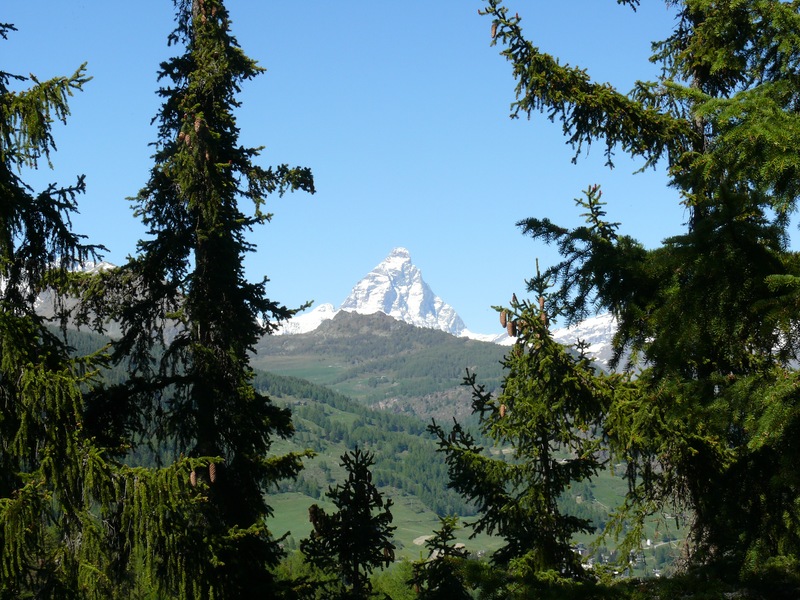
[{"xmin": 339, "ymin": 248, "xmax": 466, "ymax": 335}]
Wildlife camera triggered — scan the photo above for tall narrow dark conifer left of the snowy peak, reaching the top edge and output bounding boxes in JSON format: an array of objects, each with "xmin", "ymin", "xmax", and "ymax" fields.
[{"xmin": 84, "ymin": 0, "xmax": 314, "ymax": 599}]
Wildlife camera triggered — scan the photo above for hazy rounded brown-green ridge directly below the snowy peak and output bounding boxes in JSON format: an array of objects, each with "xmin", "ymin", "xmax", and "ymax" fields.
[{"xmin": 252, "ymin": 311, "xmax": 508, "ymax": 421}]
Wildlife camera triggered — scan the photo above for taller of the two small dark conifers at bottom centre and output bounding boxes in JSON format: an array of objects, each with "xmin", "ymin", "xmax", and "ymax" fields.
[{"xmin": 300, "ymin": 448, "xmax": 395, "ymax": 599}]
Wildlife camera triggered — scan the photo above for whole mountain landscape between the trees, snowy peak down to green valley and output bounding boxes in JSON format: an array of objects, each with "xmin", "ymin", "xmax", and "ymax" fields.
[{"xmin": 39, "ymin": 248, "xmax": 644, "ymax": 560}]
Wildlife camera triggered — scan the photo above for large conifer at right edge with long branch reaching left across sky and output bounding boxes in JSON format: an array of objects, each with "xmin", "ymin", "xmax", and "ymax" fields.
[{"xmin": 486, "ymin": 0, "xmax": 800, "ymax": 575}]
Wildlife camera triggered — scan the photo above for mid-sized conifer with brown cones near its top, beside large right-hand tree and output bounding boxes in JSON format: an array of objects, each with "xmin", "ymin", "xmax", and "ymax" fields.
[{"xmin": 429, "ymin": 292, "xmax": 624, "ymax": 586}]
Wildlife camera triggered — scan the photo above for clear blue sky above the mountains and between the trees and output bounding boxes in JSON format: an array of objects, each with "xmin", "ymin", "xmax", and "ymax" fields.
[{"xmin": 0, "ymin": 0, "xmax": 685, "ymax": 333}]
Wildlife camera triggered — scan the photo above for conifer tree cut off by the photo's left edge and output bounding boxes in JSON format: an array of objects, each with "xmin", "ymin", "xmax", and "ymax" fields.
[{"xmin": 0, "ymin": 24, "xmax": 115, "ymax": 598}]
